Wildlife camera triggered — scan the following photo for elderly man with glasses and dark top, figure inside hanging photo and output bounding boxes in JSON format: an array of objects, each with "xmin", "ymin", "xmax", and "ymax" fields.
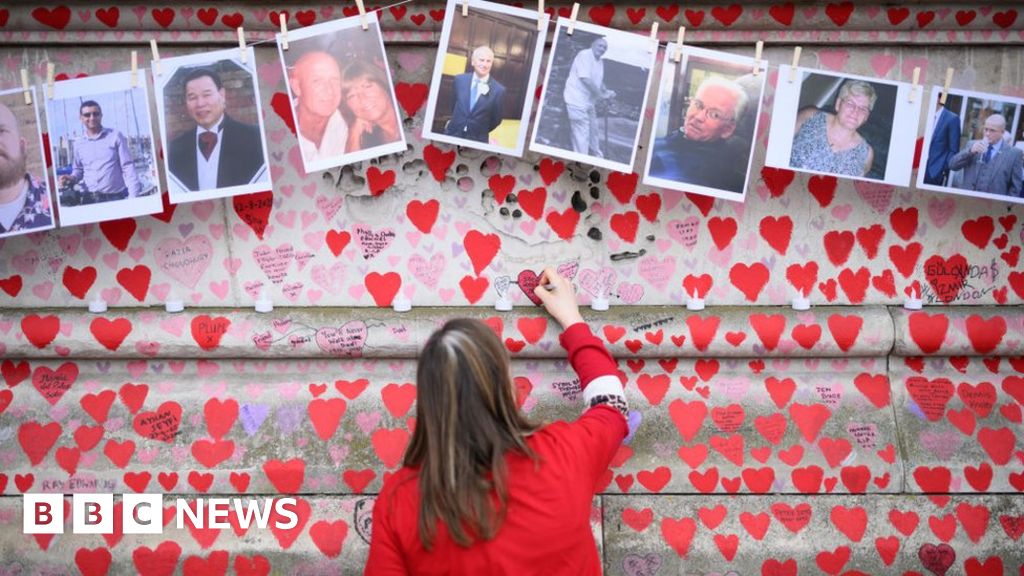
[{"xmin": 648, "ymin": 75, "xmax": 756, "ymax": 194}]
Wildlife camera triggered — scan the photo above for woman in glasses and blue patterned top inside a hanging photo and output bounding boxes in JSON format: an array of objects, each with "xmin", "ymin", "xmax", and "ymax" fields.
[{"xmin": 790, "ymin": 80, "xmax": 878, "ymax": 176}]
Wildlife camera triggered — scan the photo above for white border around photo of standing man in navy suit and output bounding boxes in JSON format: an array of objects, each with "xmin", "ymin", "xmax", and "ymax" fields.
[{"xmin": 423, "ymin": 0, "xmax": 551, "ymax": 158}]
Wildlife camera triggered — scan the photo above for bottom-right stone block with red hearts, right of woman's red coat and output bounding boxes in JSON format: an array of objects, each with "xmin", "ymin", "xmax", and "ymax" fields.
[{"xmin": 603, "ymin": 495, "xmax": 1024, "ymax": 575}]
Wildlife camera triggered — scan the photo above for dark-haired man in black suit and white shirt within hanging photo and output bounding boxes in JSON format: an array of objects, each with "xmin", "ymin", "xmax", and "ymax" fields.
[{"xmin": 168, "ymin": 68, "xmax": 266, "ymax": 192}]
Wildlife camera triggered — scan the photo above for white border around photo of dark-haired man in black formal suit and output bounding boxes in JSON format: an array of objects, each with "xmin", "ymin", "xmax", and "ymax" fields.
[{"xmin": 153, "ymin": 46, "xmax": 273, "ymax": 203}]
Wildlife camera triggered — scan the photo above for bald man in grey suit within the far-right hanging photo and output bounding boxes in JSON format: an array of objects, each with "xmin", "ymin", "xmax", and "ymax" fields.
[{"xmin": 949, "ymin": 114, "xmax": 1024, "ymax": 197}]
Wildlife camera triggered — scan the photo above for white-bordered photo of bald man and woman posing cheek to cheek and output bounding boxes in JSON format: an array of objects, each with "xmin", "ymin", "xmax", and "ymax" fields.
[{"xmin": 278, "ymin": 11, "xmax": 406, "ymax": 173}]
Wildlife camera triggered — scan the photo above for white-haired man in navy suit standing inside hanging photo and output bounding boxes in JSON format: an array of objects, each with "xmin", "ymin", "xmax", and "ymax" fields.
[{"xmin": 444, "ymin": 46, "xmax": 505, "ymax": 142}]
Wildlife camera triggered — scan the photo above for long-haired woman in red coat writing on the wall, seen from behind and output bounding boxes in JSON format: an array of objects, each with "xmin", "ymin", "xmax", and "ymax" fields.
[{"xmin": 366, "ymin": 269, "xmax": 628, "ymax": 576}]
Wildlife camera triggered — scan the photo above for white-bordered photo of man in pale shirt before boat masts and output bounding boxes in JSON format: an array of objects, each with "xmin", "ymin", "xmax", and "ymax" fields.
[{"xmin": 46, "ymin": 69, "xmax": 164, "ymax": 227}]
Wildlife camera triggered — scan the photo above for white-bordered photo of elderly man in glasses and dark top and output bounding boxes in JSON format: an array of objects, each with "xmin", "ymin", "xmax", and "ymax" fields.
[{"xmin": 643, "ymin": 43, "xmax": 768, "ymax": 202}]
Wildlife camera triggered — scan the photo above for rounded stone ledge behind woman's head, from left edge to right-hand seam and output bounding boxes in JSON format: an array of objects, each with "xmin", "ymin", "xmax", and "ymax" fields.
[{"xmin": 0, "ymin": 306, "xmax": 893, "ymax": 359}]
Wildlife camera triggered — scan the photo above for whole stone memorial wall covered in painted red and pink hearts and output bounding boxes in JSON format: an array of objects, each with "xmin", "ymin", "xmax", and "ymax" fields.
[{"xmin": 0, "ymin": 0, "xmax": 1024, "ymax": 576}]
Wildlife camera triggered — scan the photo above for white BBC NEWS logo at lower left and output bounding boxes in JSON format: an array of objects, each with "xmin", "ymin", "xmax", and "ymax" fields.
[{"xmin": 23, "ymin": 494, "xmax": 299, "ymax": 534}]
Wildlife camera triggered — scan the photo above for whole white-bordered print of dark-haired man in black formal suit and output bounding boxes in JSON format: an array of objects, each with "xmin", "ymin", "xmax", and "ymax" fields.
[{"xmin": 154, "ymin": 46, "xmax": 272, "ymax": 204}]
